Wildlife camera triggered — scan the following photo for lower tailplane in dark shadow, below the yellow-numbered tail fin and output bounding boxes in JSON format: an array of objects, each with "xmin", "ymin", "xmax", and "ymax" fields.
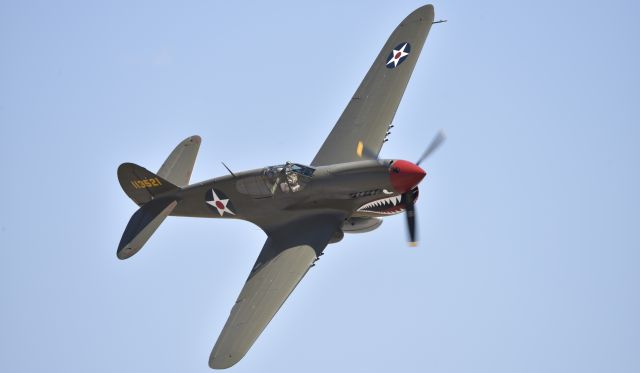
[{"xmin": 117, "ymin": 199, "xmax": 178, "ymax": 259}]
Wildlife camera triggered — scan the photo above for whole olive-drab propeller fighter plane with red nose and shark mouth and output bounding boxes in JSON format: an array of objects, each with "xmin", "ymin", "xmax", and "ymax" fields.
[{"xmin": 117, "ymin": 5, "xmax": 445, "ymax": 369}]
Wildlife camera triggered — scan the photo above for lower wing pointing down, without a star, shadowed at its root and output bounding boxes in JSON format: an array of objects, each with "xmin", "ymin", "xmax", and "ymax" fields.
[{"xmin": 209, "ymin": 212, "xmax": 345, "ymax": 369}]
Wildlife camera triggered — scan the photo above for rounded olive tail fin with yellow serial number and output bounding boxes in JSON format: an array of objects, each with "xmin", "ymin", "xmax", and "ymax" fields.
[{"xmin": 118, "ymin": 163, "xmax": 180, "ymax": 206}]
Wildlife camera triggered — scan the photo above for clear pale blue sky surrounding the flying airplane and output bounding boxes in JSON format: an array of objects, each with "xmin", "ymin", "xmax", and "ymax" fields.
[{"xmin": 0, "ymin": 0, "xmax": 640, "ymax": 373}]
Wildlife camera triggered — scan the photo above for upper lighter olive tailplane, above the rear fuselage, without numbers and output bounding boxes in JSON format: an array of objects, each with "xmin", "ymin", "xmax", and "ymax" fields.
[{"xmin": 158, "ymin": 135, "xmax": 201, "ymax": 187}]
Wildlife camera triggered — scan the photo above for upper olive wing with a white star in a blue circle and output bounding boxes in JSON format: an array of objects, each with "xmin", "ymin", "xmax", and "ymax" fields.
[{"xmin": 311, "ymin": 5, "xmax": 434, "ymax": 166}]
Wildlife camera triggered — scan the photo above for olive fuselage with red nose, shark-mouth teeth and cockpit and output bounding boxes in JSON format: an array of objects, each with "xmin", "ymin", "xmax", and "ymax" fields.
[{"xmin": 172, "ymin": 159, "xmax": 426, "ymax": 225}]
